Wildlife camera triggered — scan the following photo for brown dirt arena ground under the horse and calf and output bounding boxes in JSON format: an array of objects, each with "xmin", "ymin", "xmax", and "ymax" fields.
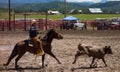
[{"xmin": 0, "ymin": 30, "xmax": 120, "ymax": 72}]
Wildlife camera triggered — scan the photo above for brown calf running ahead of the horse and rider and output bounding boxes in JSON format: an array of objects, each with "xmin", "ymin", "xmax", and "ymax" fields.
[{"xmin": 73, "ymin": 44, "xmax": 113, "ymax": 67}]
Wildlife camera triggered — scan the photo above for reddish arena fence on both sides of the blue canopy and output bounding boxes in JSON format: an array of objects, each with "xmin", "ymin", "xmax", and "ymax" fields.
[{"xmin": 0, "ymin": 19, "xmax": 120, "ymax": 31}]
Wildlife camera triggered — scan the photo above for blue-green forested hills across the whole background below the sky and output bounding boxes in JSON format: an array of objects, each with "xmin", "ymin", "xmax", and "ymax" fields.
[{"xmin": 0, "ymin": 0, "xmax": 120, "ymax": 13}]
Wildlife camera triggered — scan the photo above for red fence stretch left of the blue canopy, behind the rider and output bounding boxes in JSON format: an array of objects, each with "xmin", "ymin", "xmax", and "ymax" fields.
[{"xmin": 0, "ymin": 19, "xmax": 62, "ymax": 31}]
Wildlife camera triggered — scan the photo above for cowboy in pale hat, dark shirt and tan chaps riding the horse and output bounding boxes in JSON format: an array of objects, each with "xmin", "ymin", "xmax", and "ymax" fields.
[{"xmin": 29, "ymin": 20, "xmax": 44, "ymax": 55}]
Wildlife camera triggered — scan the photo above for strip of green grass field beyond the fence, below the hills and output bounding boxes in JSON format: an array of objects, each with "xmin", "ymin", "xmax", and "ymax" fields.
[{"xmin": 0, "ymin": 13, "xmax": 120, "ymax": 20}]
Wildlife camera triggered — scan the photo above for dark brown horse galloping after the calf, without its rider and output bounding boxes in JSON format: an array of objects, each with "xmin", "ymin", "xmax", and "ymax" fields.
[{"xmin": 4, "ymin": 29, "xmax": 63, "ymax": 69}]
